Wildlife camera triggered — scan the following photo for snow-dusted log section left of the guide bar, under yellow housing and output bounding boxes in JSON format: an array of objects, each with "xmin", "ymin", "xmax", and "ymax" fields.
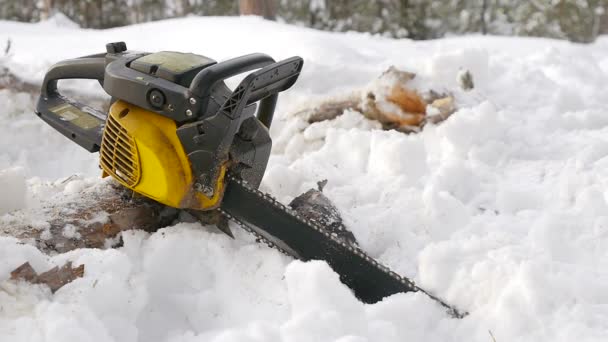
[{"xmin": 0, "ymin": 182, "xmax": 179, "ymax": 253}]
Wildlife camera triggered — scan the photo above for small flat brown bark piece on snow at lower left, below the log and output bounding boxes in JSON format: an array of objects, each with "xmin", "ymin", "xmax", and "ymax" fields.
[{"xmin": 11, "ymin": 261, "xmax": 84, "ymax": 293}]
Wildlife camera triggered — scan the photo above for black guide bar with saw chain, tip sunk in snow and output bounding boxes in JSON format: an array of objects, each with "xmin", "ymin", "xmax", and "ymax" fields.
[{"xmin": 218, "ymin": 175, "xmax": 467, "ymax": 318}]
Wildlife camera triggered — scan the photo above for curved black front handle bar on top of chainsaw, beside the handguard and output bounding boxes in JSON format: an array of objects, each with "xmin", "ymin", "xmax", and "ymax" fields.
[{"xmin": 190, "ymin": 53, "xmax": 275, "ymax": 98}]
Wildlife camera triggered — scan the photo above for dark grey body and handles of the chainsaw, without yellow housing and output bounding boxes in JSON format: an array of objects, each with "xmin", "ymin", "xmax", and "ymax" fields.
[{"xmin": 36, "ymin": 42, "xmax": 303, "ymax": 192}]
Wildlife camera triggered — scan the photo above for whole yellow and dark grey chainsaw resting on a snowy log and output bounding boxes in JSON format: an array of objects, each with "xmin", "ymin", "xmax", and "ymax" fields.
[{"xmin": 36, "ymin": 42, "xmax": 463, "ymax": 317}]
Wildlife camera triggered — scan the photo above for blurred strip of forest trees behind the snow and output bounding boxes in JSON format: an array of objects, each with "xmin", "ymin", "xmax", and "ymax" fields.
[{"xmin": 0, "ymin": 0, "xmax": 608, "ymax": 42}]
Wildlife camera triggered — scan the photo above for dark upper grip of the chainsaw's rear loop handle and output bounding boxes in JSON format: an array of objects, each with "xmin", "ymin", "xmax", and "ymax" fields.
[{"xmin": 41, "ymin": 55, "xmax": 106, "ymax": 98}]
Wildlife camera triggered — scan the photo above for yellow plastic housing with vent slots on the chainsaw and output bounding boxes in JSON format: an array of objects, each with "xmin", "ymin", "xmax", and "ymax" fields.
[{"xmin": 100, "ymin": 101, "xmax": 226, "ymax": 210}]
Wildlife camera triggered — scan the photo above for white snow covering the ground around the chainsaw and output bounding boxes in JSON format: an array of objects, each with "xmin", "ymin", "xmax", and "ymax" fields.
[{"xmin": 0, "ymin": 17, "xmax": 608, "ymax": 342}]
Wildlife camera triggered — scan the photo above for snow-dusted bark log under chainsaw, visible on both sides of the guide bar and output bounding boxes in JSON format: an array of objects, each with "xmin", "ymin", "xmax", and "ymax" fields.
[{"xmin": 0, "ymin": 179, "xmax": 356, "ymax": 254}]
